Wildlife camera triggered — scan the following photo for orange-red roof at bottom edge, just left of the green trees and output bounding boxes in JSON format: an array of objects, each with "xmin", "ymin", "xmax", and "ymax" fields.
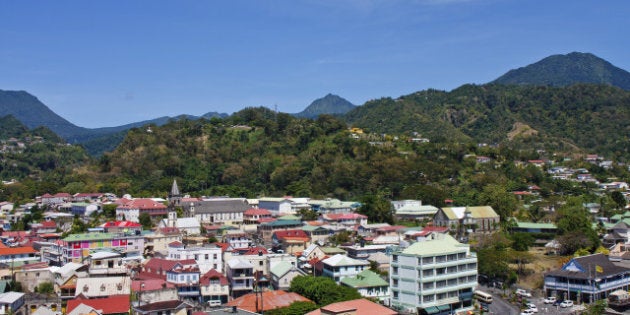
[{"xmin": 226, "ymin": 290, "xmax": 312, "ymax": 312}]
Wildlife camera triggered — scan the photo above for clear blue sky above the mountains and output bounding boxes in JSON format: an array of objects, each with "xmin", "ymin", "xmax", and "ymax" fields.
[{"xmin": 0, "ymin": 0, "xmax": 630, "ymax": 128}]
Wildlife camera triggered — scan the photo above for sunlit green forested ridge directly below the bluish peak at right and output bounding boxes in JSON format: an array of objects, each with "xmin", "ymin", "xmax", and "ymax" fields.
[{"xmin": 344, "ymin": 84, "xmax": 630, "ymax": 159}]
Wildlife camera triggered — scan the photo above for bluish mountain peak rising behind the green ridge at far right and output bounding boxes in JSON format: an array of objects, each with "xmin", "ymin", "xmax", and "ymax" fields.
[{"xmin": 491, "ymin": 52, "xmax": 630, "ymax": 90}]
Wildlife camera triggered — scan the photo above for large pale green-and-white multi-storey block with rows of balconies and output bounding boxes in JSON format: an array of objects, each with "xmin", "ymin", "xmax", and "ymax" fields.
[{"xmin": 389, "ymin": 233, "xmax": 477, "ymax": 314}]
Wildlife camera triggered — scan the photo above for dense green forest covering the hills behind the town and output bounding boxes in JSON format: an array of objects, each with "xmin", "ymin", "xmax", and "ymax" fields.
[{"xmin": 0, "ymin": 85, "xmax": 630, "ymax": 222}]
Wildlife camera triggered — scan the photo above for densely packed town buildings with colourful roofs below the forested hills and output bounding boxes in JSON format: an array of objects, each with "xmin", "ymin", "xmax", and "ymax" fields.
[{"xmin": 0, "ymin": 178, "xmax": 630, "ymax": 315}]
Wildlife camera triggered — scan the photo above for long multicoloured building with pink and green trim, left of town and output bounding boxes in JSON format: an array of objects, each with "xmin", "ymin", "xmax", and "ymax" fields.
[{"xmin": 42, "ymin": 233, "xmax": 144, "ymax": 266}]
